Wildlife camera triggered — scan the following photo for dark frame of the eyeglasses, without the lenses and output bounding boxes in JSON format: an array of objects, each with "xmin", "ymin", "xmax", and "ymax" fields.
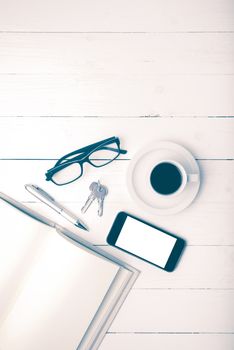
[{"xmin": 45, "ymin": 136, "xmax": 127, "ymax": 186}]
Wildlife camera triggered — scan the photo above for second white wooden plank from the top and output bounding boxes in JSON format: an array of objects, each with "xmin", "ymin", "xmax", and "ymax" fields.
[{"xmin": 0, "ymin": 33, "xmax": 234, "ymax": 75}]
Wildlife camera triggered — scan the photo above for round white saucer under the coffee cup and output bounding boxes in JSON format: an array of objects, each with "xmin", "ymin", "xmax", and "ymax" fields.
[{"xmin": 127, "ymin": 141, "xmax": 200, "ymax": 215}]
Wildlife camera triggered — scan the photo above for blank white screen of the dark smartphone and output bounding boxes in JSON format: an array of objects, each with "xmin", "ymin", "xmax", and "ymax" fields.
[{"xmin": 115, "ymin": 216, "xmax": 177, "ymax": 268}]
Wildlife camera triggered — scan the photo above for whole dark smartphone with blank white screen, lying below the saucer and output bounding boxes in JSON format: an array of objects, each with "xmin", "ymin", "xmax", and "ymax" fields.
[{"xmin": 107, "ymin": 212, "xmax": 185, "ymax": 272}]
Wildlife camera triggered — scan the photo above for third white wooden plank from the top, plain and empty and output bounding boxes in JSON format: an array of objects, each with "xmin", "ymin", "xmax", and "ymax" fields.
[{"xmin": 0, "ymin": 74, "xmax": 234, "ymax": 117}]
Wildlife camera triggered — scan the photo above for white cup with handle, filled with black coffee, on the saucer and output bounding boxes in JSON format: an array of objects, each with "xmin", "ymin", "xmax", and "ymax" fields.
[{"xmin": 150, "ymin": 160, "xmax": 199, "ymax": 196}]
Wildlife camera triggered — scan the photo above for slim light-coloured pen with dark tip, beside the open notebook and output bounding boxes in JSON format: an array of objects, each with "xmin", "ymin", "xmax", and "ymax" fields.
[{"xmin": 25, "ymin": 184, "xmax": 88, "ymax": 231}]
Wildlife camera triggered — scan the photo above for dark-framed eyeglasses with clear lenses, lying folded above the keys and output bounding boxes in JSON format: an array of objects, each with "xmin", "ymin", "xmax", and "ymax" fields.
[{"xmin": 45, "ymin": 136, "xmax": 127, "ymax": 186}]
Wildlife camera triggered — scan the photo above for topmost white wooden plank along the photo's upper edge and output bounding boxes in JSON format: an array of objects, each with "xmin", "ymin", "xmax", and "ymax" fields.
[{"xmin": 0, "ymin": 0, "xmax": 233, "ymax": 32}]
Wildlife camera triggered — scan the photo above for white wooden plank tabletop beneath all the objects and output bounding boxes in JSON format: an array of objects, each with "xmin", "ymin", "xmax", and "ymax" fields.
[{"xmin": 0, "ymin": 0, "xmax": 234, "ymax": 350}]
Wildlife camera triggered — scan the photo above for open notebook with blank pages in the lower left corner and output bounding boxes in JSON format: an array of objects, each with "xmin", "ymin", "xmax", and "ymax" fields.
[{"xmin": 0, "ymin": 193, "xmax": 138, "ymax": 350}]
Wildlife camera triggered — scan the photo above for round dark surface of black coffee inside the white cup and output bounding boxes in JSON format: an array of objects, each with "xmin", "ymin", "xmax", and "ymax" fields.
[{"xmin": 150, "ymin": 162, "xmax": 182, "ymax": 194}]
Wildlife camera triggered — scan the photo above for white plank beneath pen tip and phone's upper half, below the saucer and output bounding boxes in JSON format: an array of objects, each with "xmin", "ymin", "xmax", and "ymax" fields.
[{"xmin": 0, "ymin": 198, "xmax": 234, "ymax": 245}]
